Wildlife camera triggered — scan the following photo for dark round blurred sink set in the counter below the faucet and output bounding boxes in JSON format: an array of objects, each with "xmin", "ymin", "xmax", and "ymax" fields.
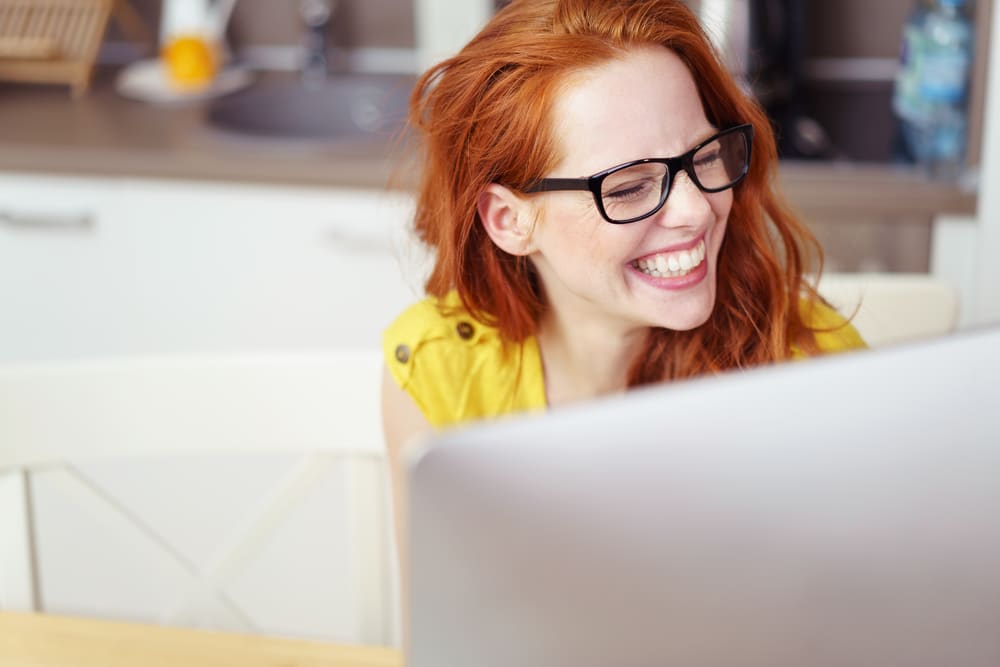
[{"xmin": 208, "ymin": 74, "xmax": 414, "ymax": 141}]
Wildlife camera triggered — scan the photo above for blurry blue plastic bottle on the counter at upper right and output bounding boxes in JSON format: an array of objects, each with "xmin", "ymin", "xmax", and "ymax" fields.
[{"xmin": 893, "ymin": 0, "xmax": 973, "ymax": 179}]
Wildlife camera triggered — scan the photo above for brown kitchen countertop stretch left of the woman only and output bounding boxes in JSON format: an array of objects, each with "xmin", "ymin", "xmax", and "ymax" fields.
[{"xmin": 0, "ymin": 71, "xmax": 412, "ymax": 188}]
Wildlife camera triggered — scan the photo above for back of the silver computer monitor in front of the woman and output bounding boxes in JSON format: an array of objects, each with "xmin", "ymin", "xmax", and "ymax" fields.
[{"xmin": 407, "ymin": 328, "xmax": 1000, "ymax": 667}]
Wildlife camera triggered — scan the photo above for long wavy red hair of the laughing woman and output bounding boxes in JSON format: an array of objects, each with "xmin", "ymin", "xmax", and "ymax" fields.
[{"xmin": 409, "ymin": 0, "xmax": 822, "ymax": 386}]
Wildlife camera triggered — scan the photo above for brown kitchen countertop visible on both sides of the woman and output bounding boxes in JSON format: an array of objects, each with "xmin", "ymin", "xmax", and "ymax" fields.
[{"xmin": 0, "ymin": 69, "xmax": 976, "ymax": 221}]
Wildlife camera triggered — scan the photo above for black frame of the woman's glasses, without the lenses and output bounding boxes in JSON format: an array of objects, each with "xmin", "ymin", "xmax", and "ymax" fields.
[{"xmin": 524, "ymin": 123, "xmax": 753, "ymax": 225}]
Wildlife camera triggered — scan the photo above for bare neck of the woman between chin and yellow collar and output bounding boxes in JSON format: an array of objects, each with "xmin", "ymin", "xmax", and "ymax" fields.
[{"xmin": 537, "ymin": 311, "xmax": 649, "ymax": 405}]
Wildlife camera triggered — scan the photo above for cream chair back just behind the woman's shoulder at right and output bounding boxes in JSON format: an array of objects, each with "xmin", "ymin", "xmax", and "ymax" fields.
[{"xmin": 819, "ymin": 273, "xmax": 959, "ymax": 347}]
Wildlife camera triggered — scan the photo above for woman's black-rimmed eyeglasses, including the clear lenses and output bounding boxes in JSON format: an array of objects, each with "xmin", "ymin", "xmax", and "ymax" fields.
[{"xmin": 524, "ymin": 124, "xmax": 753, "ymax": 225}]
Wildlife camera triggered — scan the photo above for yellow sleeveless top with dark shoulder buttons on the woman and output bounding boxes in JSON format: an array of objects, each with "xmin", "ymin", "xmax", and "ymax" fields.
[{"xmin": 382, "ymin": 292, "xmax": 866, "ymax": 427}]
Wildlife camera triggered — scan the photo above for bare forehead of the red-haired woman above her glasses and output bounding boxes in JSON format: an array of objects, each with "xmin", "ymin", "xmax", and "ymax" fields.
[{"xmin": 552, "ymin": 46, "xmax": 712, "ymax": 177}]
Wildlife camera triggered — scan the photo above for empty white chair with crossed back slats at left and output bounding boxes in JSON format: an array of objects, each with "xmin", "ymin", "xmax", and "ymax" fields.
[{"xmin": 0, "ymin": 349, "xmax": 398, "ymax": 645}]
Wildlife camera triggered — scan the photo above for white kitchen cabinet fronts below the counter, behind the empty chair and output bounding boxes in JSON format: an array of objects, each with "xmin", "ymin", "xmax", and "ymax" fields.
[{"xmin": 0, "ymin": 174, "xmax": 416, "ymax": 643}]
